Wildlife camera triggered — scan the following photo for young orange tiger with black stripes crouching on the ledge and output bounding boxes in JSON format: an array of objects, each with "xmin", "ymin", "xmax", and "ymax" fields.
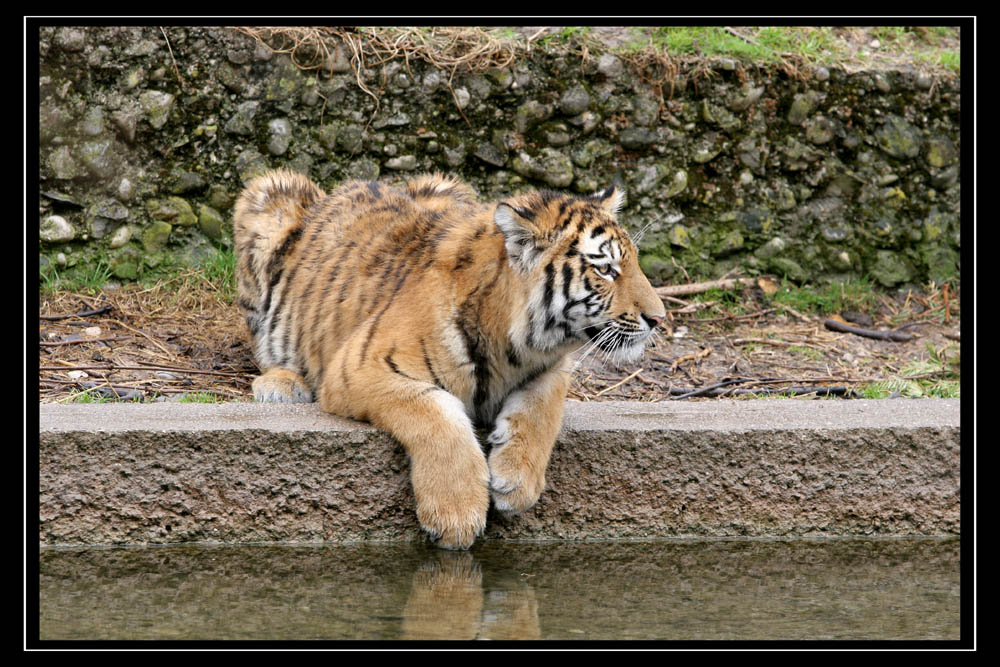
[{"xmin": 233, "ymin": 169, "xmax": 666, "ymax": 550}]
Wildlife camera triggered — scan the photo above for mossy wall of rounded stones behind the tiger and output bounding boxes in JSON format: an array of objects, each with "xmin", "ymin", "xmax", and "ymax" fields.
[{"xmin": 37, "ymin": 27, "xmax": 961, "ymax": 286}]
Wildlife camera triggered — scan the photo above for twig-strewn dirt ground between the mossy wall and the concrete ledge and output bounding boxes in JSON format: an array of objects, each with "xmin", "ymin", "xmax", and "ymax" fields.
[{"xmin": 38, "ymin": 278, "xmax": 960, "ymax": 402}]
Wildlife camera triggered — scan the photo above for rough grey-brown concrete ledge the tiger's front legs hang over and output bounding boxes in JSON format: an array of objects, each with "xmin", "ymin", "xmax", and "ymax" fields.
[{"xmin": 39, "ymin": 399, "xmax": 960, "ymax": 545}]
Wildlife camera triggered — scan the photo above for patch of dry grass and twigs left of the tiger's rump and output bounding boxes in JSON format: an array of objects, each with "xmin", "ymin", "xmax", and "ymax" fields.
[{"xmin": 39, "ymin": 276, "xmax": 257, "ymax": 401}]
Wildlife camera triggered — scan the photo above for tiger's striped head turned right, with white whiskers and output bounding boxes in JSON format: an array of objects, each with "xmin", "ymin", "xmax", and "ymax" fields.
[{"xmin": 494, "ymin": 186, "xmax": 666, "ymax": 364}]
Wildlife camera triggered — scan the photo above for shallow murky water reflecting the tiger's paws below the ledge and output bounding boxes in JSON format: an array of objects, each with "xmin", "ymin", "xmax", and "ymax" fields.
[{"xmin": 39, "ymin": 539, "xmax": 960, "ymax": 640}]
